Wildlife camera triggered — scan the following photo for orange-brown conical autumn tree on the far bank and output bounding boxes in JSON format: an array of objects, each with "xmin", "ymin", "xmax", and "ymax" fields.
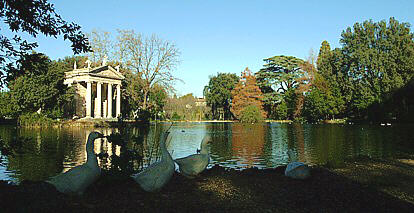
[{"xmin": 231, "ymin": 68, "xmax": 266, "ymax": 119}]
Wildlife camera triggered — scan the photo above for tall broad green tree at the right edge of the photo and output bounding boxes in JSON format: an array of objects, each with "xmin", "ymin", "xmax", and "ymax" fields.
[{"xmin": 336, "ymin": 18, "xmax": 414, "ymax": 118}]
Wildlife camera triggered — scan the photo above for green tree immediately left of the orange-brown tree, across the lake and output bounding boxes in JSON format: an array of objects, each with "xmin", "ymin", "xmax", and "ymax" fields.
[{"xmin": 204, "ymin": 73, "xmax": 239, "ymax": 119}]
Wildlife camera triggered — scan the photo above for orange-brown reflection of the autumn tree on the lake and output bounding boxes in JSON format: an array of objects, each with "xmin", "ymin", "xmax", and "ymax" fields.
[{"xmin": 232, "ymin": 123, "xmax": 267, "ymax": 167}]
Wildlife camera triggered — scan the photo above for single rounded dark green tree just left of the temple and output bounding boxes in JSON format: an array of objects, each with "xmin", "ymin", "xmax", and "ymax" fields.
[{"xmin": 8, "ymin": 53, "xmax": 74, "ymax": 117}]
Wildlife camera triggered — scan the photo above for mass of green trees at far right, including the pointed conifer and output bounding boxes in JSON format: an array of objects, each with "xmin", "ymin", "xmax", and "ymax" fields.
[{"xmin": 300, "ymin": 18, "xmax": 414, "ymax": 120}]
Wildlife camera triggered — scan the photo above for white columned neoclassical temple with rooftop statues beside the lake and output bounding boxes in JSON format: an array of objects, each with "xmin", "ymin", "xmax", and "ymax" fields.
[{"xmin": 64, "ymin": 61, "xmax": 125, "ymax": 119}]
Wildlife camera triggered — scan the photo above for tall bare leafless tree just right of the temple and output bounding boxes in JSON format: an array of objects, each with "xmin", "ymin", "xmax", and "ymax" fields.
[{"xmin": 117, "ymin": 30, "xmax": 180, "ymax": 110}]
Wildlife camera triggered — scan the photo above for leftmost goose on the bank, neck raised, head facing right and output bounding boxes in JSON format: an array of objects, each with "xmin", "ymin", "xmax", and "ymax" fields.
[{"xmin": 46, "ymin": 132, "xmax": 105, "ymax": 195}]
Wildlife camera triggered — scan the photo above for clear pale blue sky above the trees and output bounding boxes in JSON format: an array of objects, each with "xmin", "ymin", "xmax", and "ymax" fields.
[{"xmin": 9, "ymin": 0, "xmax": 414, "ymax": 97}]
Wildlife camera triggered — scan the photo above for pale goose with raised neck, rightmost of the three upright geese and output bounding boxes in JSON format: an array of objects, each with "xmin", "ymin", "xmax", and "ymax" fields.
[{"xmin": 174, "ymin": 135, "xmax": 211, "ymax": 178}]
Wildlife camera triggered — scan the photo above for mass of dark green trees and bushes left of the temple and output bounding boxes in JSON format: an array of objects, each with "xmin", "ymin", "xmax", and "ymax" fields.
[{"xmin": 0, "ymin": 53, "xmax": 84, "ymax": 120}]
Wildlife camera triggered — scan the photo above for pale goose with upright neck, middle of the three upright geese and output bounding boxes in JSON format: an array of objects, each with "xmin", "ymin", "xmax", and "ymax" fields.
[{"xmin": 131, "ymin": 131, "xmax": 175, "ymax": 192}]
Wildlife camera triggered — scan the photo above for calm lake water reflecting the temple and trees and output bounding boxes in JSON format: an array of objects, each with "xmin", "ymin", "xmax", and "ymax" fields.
[{"xmin": 0, "ymin": 123, "xmax": 414, "ymax": 182}]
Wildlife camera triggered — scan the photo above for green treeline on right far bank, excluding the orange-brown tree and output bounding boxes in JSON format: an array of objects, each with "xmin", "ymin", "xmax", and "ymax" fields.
[{"xmin": 204, "ymin": 18, "xmax": 414, "ymax": 122}]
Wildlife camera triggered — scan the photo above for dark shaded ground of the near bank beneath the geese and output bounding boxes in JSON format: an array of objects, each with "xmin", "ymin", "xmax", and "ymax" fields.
[{"xmin": 0, "ymin": 159, "xmax": 414, "ymax": 212}]
